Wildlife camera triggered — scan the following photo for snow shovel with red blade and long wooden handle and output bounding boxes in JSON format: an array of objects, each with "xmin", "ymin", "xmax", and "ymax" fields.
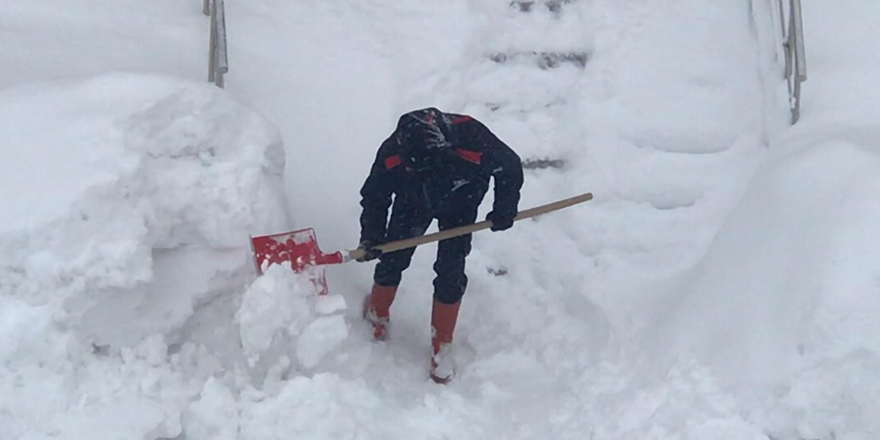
[{"xmin": 251, "ymin": 193, "xmax": 593, "ymax": 295}]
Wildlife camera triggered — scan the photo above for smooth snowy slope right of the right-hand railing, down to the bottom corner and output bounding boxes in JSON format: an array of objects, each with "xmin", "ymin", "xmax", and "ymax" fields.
[{"xmin": 649, "ymin": 0, "xmax": 880, "ymax": 439}]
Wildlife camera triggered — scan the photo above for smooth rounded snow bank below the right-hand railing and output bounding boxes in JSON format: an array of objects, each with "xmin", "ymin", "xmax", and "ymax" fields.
[{"xmin": 652, "ymin": 140, "xmax": 880, "ymax": 438}]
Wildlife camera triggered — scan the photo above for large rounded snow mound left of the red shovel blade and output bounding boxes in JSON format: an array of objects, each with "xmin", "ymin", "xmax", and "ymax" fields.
[{"xmin": 0, "ymin": 75, "xmax": 286, "ymax": 343}]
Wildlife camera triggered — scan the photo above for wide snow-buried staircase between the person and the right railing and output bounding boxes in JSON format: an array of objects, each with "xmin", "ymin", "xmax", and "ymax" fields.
[{"xmin": 449, "ymin": 0, "xmax": 761, "ymax": 280}]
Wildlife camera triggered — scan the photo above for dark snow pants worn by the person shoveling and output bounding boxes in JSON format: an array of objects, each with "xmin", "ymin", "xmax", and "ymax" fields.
[{"xmin": 373, "ymin": 201, "xmax": 479, "ymax": 304}]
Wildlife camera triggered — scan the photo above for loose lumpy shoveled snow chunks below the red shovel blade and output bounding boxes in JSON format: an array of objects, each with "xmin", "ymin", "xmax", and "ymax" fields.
[{"xmin": 0, "ymin": 266, "xmax": 350, "ymax": 440}]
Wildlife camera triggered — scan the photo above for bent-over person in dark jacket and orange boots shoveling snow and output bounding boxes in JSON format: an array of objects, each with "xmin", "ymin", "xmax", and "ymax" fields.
[{"xmin": 358, "ymin": 108, "xmax": 523, "ymax": 383}]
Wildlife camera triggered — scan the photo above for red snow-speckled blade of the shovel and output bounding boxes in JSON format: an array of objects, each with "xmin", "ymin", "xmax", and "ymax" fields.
[{"xmin": 251, "ymin": 228, "xmax": 344, "ymax": 295}]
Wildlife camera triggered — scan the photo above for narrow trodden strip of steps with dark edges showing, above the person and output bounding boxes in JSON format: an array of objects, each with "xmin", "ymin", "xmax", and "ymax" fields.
[{"xmin": 466, "ymin": 0, "xmax": 591, "ymax": 170}]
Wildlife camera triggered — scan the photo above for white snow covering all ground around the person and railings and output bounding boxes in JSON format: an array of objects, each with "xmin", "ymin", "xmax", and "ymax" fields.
[{"xmin": 0, "ymin": 0, "xmax": 880, "ymax": 440}]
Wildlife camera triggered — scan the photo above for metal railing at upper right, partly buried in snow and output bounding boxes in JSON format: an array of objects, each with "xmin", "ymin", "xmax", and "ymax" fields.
[{"xmin": 779, "ymin": 0, "xmax": 807, "ymax": 124}]
